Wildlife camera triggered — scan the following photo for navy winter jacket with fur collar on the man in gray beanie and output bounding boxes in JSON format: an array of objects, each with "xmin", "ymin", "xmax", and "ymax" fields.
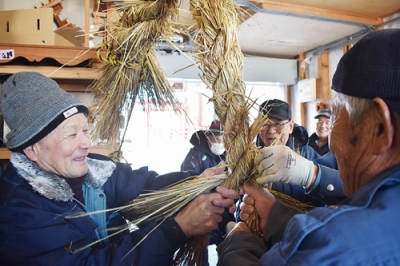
[{"xmin": 0, "ymin": 153, "xmax": 194, "ymax": 265}]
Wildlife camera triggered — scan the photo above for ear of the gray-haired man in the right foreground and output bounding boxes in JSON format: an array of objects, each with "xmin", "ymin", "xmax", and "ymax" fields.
[{"xmin": 371, "ymin": 98, "xmax": 395, "ymax": 155}]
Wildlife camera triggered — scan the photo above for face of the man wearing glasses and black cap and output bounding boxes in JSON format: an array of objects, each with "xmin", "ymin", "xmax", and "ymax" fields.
[{"xmin": 260, "ymin": 117, "xmax": 294, "ymax": 146}]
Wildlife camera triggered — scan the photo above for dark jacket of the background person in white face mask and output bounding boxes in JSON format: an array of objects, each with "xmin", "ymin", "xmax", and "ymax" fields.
[{"xmin": 181, "ymin": 130, "xmax": 225, "ymax": 173}]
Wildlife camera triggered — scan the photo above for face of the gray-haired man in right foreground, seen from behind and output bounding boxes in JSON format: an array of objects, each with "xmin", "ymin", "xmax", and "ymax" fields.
[{"xmin": 329, "ymin": 107, "xmax": 373, "ymax": 196}]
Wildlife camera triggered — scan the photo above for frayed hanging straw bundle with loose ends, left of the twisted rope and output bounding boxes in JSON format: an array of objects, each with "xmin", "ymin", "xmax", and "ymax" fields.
[{"xmin": 90, "ymin": 0, "xmax": 181, "ymax": 145}]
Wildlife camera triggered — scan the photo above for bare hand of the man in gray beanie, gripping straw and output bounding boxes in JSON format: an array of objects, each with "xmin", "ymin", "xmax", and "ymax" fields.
[{"xmin": 175, "ymin": 186, "xmax": 239, "ymax": 237}]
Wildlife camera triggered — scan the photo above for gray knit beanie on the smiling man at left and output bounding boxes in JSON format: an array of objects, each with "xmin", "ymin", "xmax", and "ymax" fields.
[{"xmin": 0, "ymin": 72, "xmax": 88, "ymax": 151}]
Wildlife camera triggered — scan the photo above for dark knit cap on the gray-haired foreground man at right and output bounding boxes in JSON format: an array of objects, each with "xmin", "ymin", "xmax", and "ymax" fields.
[{"xmin": 332, "ymin": 29, "xmax": 400, "ymax": 113}]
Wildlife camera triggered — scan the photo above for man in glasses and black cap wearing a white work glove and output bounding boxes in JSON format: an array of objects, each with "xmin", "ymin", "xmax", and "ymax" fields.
[{"xmin": 256, "ymin": 100, "xmax": 346, "ymax": 206}]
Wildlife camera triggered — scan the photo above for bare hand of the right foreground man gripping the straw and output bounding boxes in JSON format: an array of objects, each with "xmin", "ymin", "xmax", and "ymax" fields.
[{"xmin": 240, "ymin": 184, "xmax": 276, "ymax": 231}]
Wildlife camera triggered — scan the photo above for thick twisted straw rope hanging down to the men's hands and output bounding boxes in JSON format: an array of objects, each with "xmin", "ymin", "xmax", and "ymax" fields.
[{"xmin": 190, "ymin": 0, "xmax": 266, "ymax": 189}]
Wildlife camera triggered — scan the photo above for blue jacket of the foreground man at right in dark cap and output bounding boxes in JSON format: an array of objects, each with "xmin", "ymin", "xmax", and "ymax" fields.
[{"xmin": 218, "ymin": 166, "xmax": 400, "ymax": 266}]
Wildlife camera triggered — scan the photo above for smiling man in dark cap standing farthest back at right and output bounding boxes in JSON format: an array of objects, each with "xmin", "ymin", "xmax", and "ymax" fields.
[{"xmin": 308, "ymin": 102, "xmax": 331, "ymax": 156}]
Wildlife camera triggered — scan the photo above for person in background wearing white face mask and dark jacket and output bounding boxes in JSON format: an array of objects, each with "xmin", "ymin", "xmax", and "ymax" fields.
[{"xmin": 181, "ymin": 120, "xmax": 225, "ymax": 173}]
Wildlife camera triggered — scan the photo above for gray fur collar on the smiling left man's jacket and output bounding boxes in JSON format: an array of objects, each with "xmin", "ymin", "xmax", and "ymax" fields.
[{"xmin": 10, "ymin": 152, "xmax": 116, "ymax": 201}]
